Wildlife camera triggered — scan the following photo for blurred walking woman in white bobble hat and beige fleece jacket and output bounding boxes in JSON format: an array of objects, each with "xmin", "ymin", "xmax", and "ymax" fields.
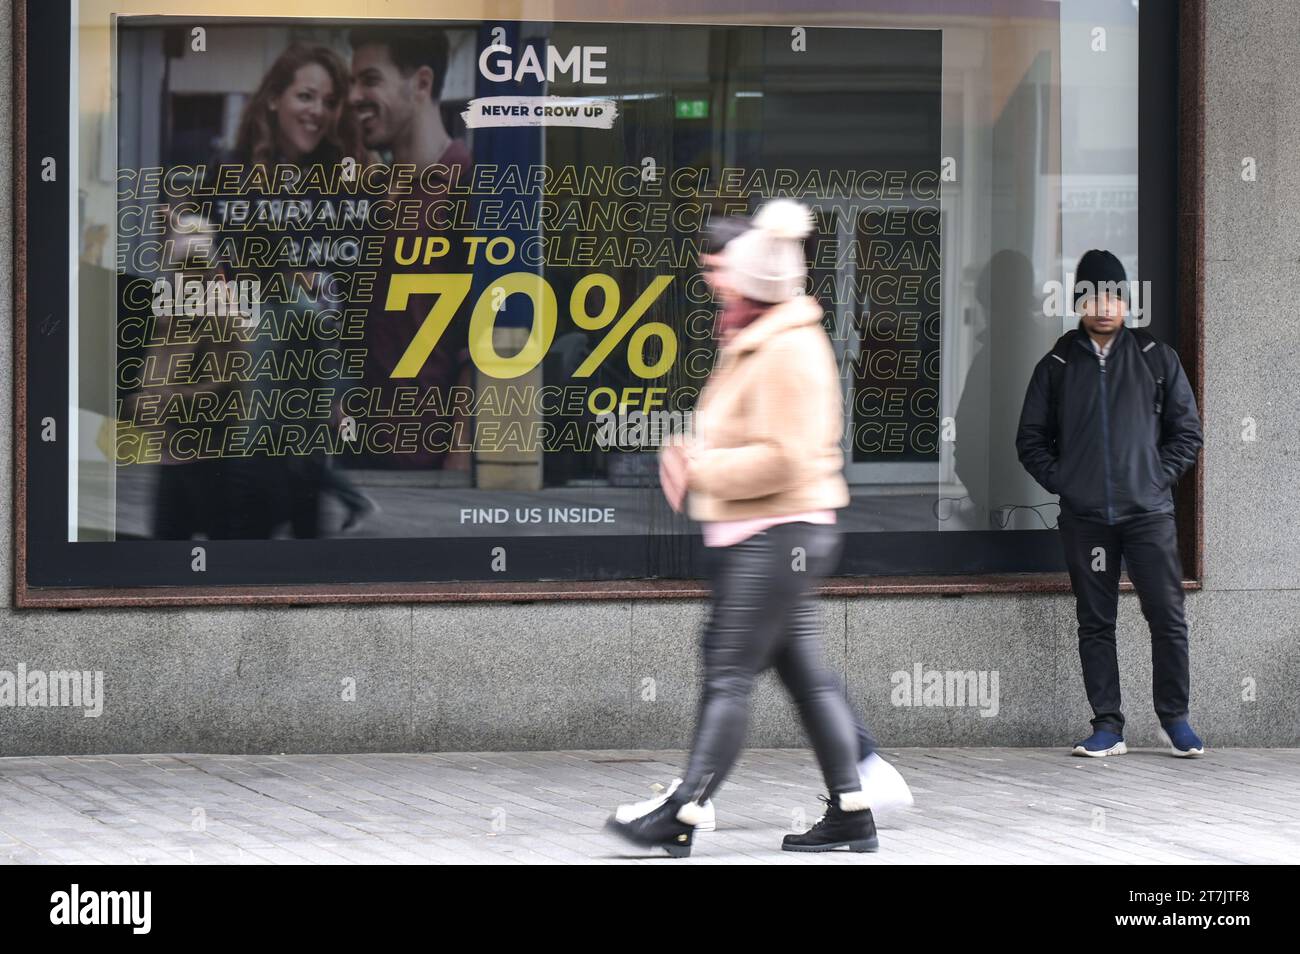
[{"xmin": 606, "ymin": 200, "xmax": 878, "ymax": 857}]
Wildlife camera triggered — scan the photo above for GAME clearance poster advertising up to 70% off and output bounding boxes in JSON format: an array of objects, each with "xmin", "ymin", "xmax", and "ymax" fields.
[{"xmin": 73, "ymin": 17, "xmax": 941, "ymax": 578}]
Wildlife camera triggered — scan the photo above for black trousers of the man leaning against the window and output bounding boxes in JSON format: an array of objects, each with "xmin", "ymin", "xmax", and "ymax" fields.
[{"xmin": 1060, "ymin": 511, "xmax": 1190, "ymax": 733}]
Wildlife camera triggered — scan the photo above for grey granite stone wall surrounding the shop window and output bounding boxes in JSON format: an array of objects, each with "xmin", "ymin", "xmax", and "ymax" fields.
[{"xmin": 0, "ymin": 0, "xmax": 1300, "ymax": 755}]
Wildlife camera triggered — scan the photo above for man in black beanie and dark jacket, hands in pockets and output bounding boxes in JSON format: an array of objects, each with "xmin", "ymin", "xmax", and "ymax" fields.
[{"xmin": 1015, "ymin": 248, "xmax": 1205, "ymax": 758}]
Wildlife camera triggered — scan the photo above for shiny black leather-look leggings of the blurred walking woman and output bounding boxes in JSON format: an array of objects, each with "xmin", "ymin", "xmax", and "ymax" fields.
[{"xmin": 673, "ymin": 522, "xmax": 866, "ymax": 802}]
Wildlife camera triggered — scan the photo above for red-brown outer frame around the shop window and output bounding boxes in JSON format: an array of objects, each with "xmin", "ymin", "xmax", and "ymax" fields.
[{"xmin": 12, "ymin": 0, "xmax": 1205, "ymax": 608}]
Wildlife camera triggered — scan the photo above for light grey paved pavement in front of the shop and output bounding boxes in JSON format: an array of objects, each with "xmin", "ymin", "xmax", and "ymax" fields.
[{"xmin": 0, "ymin": 749, "xmax": 1300, "ymax": 864}]
